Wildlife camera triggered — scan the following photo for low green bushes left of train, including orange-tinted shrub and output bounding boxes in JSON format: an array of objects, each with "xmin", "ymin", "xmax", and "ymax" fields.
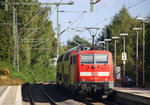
[{"xmin": 0, "ymin": 61, "xmax": 55, "ymax": 83}]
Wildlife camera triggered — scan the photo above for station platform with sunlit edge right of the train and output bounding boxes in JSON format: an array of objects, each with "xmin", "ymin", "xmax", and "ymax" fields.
[{"xmin": 114, "ymin": 87, "xmax": 150, "ymax": 105}]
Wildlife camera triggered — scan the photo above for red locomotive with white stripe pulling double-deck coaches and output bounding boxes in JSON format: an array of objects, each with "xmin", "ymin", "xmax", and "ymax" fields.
[{"xmin": 56, "ymin": 45, "xmax": 114, "ymax": 98}]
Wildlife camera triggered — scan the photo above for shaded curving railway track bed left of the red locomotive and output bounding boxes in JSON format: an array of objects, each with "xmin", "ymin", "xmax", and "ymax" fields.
[{"xmin": 25, "ymin": 83, "xmax": 117, "ymax": 105}]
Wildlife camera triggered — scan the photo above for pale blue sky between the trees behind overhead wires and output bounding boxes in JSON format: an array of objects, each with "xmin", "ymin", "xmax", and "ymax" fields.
[{"xmin": 39, "ymin": 0, "xmax": 150, "ymax": 44}]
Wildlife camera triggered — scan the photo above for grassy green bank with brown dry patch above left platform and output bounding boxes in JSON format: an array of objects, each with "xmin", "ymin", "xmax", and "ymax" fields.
[{"xmin": 0, "ymin": 62, "xmax": 55, "ymax": 85}]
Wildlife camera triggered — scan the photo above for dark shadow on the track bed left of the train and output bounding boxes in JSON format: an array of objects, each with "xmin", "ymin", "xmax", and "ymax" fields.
[{"xmin": 22, "ymin": 83, "xmax": 72, "ymax": 103}]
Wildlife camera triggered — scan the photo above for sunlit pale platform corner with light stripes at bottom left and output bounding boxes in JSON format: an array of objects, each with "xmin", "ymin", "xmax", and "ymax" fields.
[{"xmin": 0, "ymin": 86, "xmax": 23, "ymax": 105}]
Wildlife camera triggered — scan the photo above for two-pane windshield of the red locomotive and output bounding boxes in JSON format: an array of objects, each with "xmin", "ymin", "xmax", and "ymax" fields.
[{"xmin": 81, "ymin": 54, "xmax": 108, "ymax": 64}]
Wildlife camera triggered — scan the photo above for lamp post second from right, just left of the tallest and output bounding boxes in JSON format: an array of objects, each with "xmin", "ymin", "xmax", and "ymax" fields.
[{"xmin": 133, "ymin": 28, "xmax": 142, "ymax": 86}]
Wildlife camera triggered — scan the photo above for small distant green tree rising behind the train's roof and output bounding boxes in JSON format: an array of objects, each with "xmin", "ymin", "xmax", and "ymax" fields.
[{"xmin": 67, "ymin": 35, "xmax": 90, "ymax": 49}]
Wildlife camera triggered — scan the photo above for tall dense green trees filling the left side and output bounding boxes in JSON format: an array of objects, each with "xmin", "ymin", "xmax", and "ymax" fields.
[{"xmin": 0, "ymin": 0, "xmax": 57, "ymax": 82}]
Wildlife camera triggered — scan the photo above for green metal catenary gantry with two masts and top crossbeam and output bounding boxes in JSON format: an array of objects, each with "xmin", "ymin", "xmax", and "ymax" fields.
[{"xmin": 4, "ymin": 0, "xmax": 73, "ymax": 71}]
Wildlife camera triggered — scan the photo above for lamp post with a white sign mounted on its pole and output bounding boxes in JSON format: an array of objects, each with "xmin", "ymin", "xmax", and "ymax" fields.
[{"xmin": 120, "ymin": 33, "xmax": 128, "ymax": 77}]
